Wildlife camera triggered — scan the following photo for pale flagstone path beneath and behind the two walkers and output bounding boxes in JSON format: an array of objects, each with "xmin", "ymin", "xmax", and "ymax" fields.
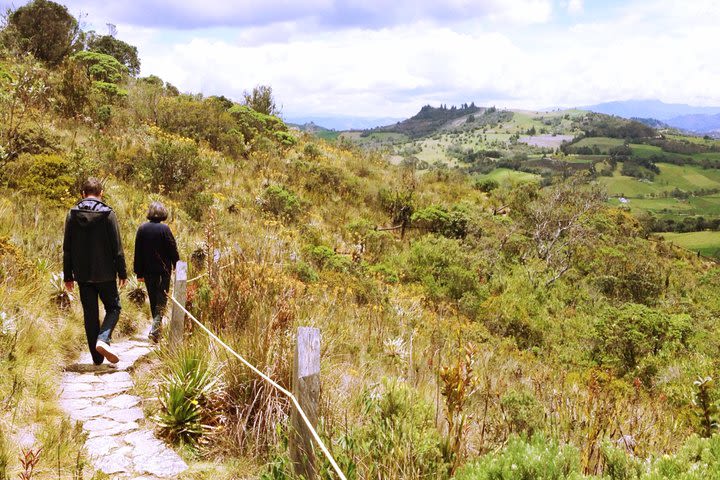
[{"xmin": 60, "ymin": 340, "xmax": 187, "ymax": 480}]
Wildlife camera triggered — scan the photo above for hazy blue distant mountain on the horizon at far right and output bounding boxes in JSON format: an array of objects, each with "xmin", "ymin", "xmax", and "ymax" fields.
[{"xmin": 580, "ymin": 100, "xmax": 720, "ymax": 134}]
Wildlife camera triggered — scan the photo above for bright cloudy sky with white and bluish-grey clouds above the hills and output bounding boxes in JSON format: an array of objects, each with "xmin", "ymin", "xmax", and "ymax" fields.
[{"xmin": 0, "ymin": 0, "xmax": 720, "ymax": 117}]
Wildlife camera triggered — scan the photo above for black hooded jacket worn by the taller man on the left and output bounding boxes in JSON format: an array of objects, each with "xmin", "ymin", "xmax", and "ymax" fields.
[{"xmin": 63, "ymin": 198, "xmax": 127, "ymax": 283}]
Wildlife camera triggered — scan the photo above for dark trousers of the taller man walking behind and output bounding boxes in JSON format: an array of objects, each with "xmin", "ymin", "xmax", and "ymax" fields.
[{"xmin": 78, "ymin": 280, "xmax": 120, "ymax": 365}]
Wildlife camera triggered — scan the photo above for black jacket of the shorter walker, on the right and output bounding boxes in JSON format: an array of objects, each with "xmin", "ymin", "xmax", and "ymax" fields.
[{"xmin": 134, "ymin": 221, "xmax": 180, "ymax": 278}]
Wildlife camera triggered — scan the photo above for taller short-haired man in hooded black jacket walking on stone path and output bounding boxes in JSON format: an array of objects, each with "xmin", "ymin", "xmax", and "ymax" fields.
[{"xmin": 63, "ymin": 177, "xmax": 127, "ymax": 365}]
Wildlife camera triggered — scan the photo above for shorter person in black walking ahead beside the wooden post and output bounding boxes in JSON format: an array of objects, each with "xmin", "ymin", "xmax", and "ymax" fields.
[{"xmin": 134, "ymin": 202, "xmax": 180, "ymax": 343}]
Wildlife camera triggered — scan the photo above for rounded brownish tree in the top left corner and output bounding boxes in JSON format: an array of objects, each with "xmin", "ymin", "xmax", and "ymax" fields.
[{"xmin": 3, "ymin": 0, "xmax": 81, "ymax": 66}]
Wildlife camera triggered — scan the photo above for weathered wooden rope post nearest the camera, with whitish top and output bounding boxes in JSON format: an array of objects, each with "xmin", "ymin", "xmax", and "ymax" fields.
[{"xmin": 290, "ymin": 327, "xmax": 320, "ymax": 480}]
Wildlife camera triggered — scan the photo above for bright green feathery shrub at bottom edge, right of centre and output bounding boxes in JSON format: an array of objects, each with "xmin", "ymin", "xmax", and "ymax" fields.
[{"xmin": 455, "ymin": 435, "xmax": 584, "ymax": 480}]
